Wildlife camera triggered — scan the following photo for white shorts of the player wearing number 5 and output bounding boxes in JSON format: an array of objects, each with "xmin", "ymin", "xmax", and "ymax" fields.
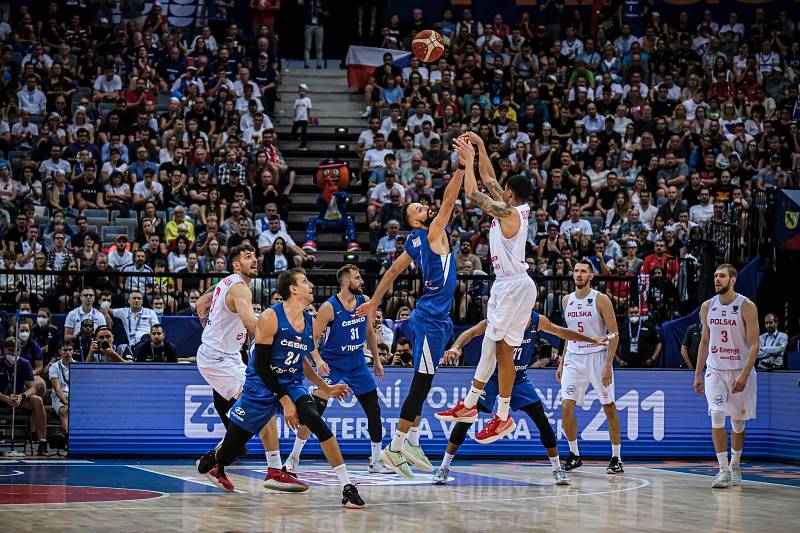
[{"xmin": 561, "ymin": 350, "xmax": 614, "ymax": 405}]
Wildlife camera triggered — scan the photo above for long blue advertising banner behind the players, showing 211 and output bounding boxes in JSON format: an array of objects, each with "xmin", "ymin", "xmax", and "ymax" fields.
[{"xmin": 69, "ymin": 363, "xmax": 800, "ymax": 460}]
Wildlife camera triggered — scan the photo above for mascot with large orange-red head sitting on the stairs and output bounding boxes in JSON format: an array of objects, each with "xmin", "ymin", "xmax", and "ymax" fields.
[{"xmin": 303, "ymin": 159, "xmax": 361, "ymax": 252}]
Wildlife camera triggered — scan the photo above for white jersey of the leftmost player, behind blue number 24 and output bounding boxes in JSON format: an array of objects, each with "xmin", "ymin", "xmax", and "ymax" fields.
[{"xmin": 203, "ymin": 274, "xmax": 247, "ymax": 357}]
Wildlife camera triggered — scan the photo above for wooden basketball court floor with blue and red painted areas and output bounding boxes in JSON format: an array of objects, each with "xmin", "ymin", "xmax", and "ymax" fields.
[{"xmin": 0, "ymin": 458, "xmax": 800, "ymax": 533}]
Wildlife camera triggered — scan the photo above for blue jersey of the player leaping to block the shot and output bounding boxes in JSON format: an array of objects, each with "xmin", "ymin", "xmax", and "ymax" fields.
[{"xmin": 406, "ymin": 229, "xmax": 456, "ymax": 317}]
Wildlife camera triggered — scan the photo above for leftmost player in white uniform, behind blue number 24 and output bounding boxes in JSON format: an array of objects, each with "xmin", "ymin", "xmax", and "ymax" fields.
[{"xmin": 195, "ymin": 244, "xmax": 308, "ymax": 492}]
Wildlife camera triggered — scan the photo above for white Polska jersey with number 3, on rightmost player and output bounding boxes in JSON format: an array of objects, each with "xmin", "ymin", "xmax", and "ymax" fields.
[{"xmin": 706, "ymin": 294, "xmax": 750, "ymax": 370}]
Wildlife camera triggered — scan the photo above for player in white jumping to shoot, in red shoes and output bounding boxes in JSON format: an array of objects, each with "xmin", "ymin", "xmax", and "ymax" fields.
[{"xmin": 437, "ymin": 132, "xmax": 536, "ymax": 444}]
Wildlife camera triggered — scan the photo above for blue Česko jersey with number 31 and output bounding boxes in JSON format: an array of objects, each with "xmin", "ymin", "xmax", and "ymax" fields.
[{"xmin": 320, "ymin": 294, "xmax": 367, "ymax": 366}]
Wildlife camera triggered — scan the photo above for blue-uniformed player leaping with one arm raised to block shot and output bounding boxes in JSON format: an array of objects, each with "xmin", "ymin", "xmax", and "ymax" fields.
[{"xmin": 358, "ymin": 157, "xmax": 464, "ymax": 479}]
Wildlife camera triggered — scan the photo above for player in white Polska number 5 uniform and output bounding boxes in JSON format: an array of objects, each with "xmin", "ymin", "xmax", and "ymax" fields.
[{"xmin": 556, "ymin": 259, "xmax": 624, "ymax": 474}]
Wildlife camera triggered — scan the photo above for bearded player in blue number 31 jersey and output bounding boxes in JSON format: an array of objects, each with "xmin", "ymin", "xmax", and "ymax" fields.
[{"xmin": 285, "ymin": 265, "xmax": 391, "ymax": 473}]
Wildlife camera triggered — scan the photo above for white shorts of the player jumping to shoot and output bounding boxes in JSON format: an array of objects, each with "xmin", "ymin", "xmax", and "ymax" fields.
[{"xmin": 484, "ymin": 274, "xmax": 536, "ymax": 346}]
